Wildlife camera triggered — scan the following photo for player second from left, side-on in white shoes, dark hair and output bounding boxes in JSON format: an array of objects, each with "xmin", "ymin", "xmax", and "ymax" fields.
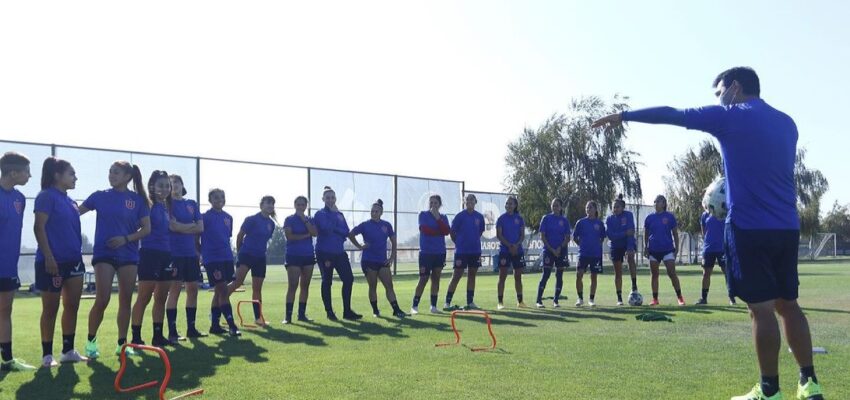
[{"xmin": 34, "ymin": 157, "xmax": 88, "ymax": 368}]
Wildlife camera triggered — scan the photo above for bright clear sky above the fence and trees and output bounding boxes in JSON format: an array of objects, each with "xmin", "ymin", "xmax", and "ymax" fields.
[{"xmin": 0, "ymin": 0, "xmax": 850, "ymax": 209}]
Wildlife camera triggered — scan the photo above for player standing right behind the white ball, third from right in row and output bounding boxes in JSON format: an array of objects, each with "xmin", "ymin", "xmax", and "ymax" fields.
[{"xmin": 605, "ymin": 195, "xmax": 638, "ymax": 306}]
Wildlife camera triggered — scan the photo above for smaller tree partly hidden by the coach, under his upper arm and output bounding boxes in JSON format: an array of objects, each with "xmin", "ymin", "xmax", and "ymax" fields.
[{"xmin": 664, "ymin": 140, "xmax": 723, "ymax": 235}]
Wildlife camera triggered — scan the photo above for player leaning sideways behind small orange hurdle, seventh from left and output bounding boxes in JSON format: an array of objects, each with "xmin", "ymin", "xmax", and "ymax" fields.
[{"xmin": 227, "ymin": 196, "xmax": 277, "ymax": 326}]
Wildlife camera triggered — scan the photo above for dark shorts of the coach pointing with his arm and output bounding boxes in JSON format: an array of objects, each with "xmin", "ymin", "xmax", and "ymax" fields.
[{"xmin": 726, "ymin": 223, "xmax": 800, "ymax": 303}]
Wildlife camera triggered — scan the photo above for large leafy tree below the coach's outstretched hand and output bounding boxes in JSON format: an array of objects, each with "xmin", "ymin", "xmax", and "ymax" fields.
[{"xmin": 505, "ymin": 96, "xmax": 642, "ymax": 231}]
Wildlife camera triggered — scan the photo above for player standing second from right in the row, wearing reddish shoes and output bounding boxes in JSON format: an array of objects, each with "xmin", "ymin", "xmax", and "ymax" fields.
[{"xmin": 643, "ymin": 195, "xmax": 685, "ymax": 306}]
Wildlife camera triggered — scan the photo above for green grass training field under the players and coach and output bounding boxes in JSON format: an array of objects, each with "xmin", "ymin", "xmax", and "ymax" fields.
[{"xmin": 0, "ymin": 263, "xmax": 850, "ymax": 399}]
